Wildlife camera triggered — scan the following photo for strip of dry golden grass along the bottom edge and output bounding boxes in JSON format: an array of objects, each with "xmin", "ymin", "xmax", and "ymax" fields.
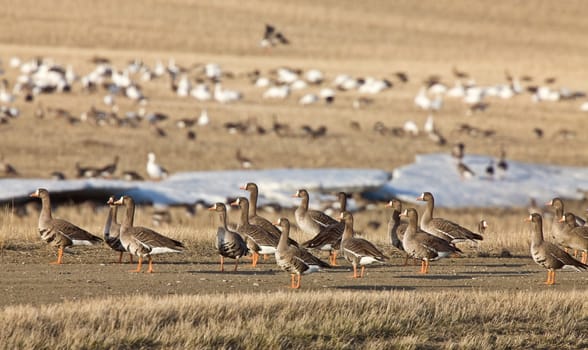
[{"xmin": 0, "ymin": 291, "xmax": 588, "ymax": 349}]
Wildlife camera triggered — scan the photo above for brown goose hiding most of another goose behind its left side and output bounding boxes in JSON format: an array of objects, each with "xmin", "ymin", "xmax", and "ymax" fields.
[{"xmin": 114, "ymin": 196, "xmax": 184, "ymax": 273}]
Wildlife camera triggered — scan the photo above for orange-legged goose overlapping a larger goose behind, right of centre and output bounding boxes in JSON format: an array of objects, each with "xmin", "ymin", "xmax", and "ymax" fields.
[{"xmin": 400, "ymin": 208, "xmax": 461, "ymax": 273}]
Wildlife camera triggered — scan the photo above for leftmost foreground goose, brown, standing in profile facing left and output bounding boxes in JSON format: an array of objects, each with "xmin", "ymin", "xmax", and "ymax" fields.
[{"xmin": 30, "ymin": 188, "xmax": 102, "ymax": 265}]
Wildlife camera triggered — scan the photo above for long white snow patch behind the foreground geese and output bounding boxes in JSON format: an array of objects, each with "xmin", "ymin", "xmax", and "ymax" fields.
[{"xmin": 0, "ymin": 154, "xmax": 588, "ymax": 208}]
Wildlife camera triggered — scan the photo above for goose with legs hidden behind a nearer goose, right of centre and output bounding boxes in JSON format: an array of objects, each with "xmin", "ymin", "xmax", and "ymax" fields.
[{"xmin": 417, "ymin": 192, "xmax": 484, "ymax": 243}]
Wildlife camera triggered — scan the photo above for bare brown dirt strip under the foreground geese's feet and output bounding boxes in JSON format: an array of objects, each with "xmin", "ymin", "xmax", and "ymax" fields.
[{"xmin": 0, "ymin": 246, "xmax": 588, "ymax": 306}]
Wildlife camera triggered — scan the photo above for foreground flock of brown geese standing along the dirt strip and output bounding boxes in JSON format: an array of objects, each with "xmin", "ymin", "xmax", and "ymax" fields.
[{"xmin": 30, "ymin": 182, "xmax": 588, "ymax": 289}]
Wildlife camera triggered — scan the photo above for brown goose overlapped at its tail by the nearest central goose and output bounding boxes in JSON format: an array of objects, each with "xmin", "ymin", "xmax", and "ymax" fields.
[{"xmin": 231, "ymin": 197, "xmax": 279, "ymax": 267}]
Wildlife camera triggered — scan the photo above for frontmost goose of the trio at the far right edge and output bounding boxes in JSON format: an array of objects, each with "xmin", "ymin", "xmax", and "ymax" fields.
[{"xmin": 525, "ymin": 213, "xmax": 588, "ymax": 285}]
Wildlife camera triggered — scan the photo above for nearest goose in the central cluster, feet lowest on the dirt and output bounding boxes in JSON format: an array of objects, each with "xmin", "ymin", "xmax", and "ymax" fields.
[{"xmin": 275, "ymin": 218, "xmax": 330, "ymax": 289}]
